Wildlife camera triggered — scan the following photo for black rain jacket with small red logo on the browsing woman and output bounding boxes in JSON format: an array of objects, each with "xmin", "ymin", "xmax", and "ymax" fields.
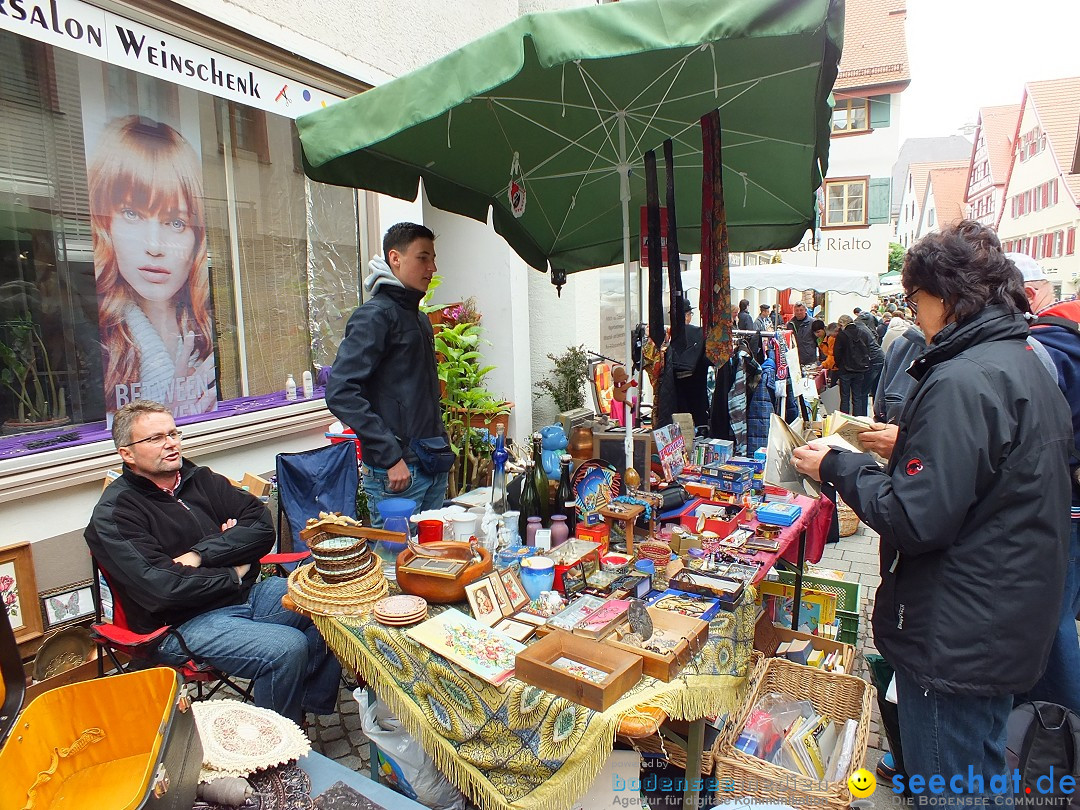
[{"xmin": 821, "ymin": 307, "xmax": 1072, "ymax": 696}]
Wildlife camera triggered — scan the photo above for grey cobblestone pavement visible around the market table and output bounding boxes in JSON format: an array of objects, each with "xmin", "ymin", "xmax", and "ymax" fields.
[{"xmin": 230, "ymin": 524, "xmax": 906, "ymax": 810}]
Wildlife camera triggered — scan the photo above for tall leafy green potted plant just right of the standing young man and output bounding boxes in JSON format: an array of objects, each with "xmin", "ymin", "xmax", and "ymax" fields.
[{"xmin": 435, "ymin": 321, "xmax": 511, "ymax": 495}]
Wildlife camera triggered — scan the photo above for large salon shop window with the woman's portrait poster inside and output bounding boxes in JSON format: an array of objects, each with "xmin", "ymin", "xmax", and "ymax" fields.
[{"xmin": 0, "ymin": 31, "xmax": 362, "ymax": 459}]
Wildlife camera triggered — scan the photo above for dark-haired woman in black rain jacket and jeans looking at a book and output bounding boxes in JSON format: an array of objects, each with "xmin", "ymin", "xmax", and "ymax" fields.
[{"xmin": 795, "ymin": 221, "xmax": 1072, "ymax": 807}]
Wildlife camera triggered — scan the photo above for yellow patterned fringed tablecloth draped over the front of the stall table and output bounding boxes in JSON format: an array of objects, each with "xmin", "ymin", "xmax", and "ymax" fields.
[{"xmin": 313, "ymin": 589, "xmax": 755, "ymax": 810}]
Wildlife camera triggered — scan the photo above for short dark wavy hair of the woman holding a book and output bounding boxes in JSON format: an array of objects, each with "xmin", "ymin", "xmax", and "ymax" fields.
[{"xmin": 901, "ymin": 219, "xmax": 1028, "ymax": 322}]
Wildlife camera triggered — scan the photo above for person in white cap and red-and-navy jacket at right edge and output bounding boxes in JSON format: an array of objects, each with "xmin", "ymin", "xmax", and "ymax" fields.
[{"xmin": 1005, "ymin": 253, "xmax": 1080, "ymax": 712}]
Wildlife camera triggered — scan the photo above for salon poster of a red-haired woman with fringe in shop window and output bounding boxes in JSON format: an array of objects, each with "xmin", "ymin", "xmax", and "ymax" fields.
[{"xmin": 80, "ymin": 71, "xmax": 217, "ymax": 424}]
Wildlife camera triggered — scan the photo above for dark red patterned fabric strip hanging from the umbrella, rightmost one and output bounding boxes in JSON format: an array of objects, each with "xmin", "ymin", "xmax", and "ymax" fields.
[{"xmin": 698, "ymin": 110, "xmax": 731, "ymax": 366}]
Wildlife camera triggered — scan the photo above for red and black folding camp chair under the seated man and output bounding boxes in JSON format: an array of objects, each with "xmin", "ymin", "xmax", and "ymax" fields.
[{"xmin": 91, "ymin": 556, "xmax": 254, "ymax": 703}]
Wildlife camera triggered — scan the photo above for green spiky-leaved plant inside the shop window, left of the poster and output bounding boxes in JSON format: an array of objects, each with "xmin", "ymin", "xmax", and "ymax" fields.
[{"xmin": 0, "ymin": 318, "xmax": 67, "ymax": 422}]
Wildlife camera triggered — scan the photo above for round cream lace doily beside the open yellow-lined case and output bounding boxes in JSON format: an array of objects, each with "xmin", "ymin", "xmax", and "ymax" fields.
[{"xmin": 191, "ymin": 700, "xmax": 311, "ymax": 782}]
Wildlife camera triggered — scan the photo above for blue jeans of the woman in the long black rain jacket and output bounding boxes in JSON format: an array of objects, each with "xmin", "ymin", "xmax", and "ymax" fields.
[{"xmin": 889, "ymin": 670, "xmax": 1012, "ymax": 807}]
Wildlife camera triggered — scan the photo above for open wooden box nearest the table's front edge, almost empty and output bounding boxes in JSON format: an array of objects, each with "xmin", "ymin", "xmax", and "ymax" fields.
[{"xmin": 515, "ymin": 630, "xmax": 642, "ymax": 712}]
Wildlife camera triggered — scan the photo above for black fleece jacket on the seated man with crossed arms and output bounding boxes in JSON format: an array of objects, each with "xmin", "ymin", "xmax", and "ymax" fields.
[{"xmin": 84, "ymin": 461, "xmax": 274, "ymax": 633}]
